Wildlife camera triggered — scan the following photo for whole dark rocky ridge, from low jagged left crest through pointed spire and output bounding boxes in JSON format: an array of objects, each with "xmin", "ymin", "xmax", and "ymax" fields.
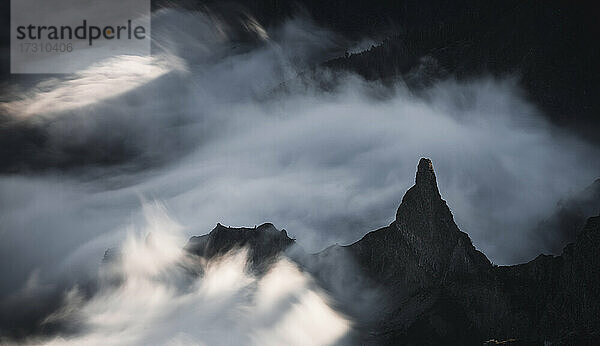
[{"xmin": 186, "ymin": 158, "xmax": 600, "ymax": 345}]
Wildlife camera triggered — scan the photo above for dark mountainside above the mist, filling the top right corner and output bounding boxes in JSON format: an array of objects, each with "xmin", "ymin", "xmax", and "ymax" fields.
[{"xmin": 170, "ymin": 0, "xmax": 600, "ymax": 143}]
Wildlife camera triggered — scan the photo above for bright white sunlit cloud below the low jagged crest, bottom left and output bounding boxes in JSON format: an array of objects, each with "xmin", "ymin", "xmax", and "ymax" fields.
[{"xmin": 24, "ymin": 204, "xmax": 351, "ymax": 345}]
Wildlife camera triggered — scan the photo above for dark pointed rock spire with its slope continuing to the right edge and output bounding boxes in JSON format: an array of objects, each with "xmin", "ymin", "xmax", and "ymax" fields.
[{"xmin": 345, "ymin": 159, "xmax": 600, "ymax": 344}]
